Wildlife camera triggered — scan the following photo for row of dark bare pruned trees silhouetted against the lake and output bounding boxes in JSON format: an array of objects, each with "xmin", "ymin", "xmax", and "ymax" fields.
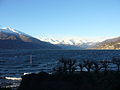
[{"xmin": 54, "ymin": 57, "xmax": 120, "ymax": 73}]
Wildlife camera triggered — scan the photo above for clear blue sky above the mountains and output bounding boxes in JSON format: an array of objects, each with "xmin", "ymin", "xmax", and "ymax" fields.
[{"xmin": 0, "ymin": 0, "xmax": 120, "ymax": 38}]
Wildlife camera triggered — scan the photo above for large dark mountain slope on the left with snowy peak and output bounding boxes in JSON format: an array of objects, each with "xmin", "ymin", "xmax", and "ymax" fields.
[{"xmin": 0, "ymin": 27, "xmax": 59, "ymax": 49}]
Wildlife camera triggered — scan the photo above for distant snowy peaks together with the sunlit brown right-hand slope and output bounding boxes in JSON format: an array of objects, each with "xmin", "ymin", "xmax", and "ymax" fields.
[{"xmin": 40, "ymin": 37, "xmax": 120, "ymax": 49}]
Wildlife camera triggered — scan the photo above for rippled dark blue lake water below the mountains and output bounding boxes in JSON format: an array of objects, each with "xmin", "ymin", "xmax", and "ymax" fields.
[{"xmin": 0, "ymin": 50, "xmax": 120, "ymax": 86}]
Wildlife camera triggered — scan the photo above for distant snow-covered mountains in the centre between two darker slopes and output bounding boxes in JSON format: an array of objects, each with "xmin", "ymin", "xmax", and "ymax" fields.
[{"xmin": 40, "ymin": 38, "xmax": 98, "ymax": 49}]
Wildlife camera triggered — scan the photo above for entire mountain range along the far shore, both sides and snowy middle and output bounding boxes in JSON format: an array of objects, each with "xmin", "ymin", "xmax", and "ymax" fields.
[{"xmin": 0, "ymin": 27, "xmax": 120, "ymax": 49}]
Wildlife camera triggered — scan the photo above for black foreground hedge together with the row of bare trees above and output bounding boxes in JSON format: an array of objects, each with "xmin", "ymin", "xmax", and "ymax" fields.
[{"xmin": 18, "ymin": 58, "xmax": 120, "ymax": 90}]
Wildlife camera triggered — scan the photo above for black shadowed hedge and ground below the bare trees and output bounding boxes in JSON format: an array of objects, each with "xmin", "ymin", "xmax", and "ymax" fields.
[{"xmin": 18, "ymin": 71, "xmax": 120, "ymax": 90}]
